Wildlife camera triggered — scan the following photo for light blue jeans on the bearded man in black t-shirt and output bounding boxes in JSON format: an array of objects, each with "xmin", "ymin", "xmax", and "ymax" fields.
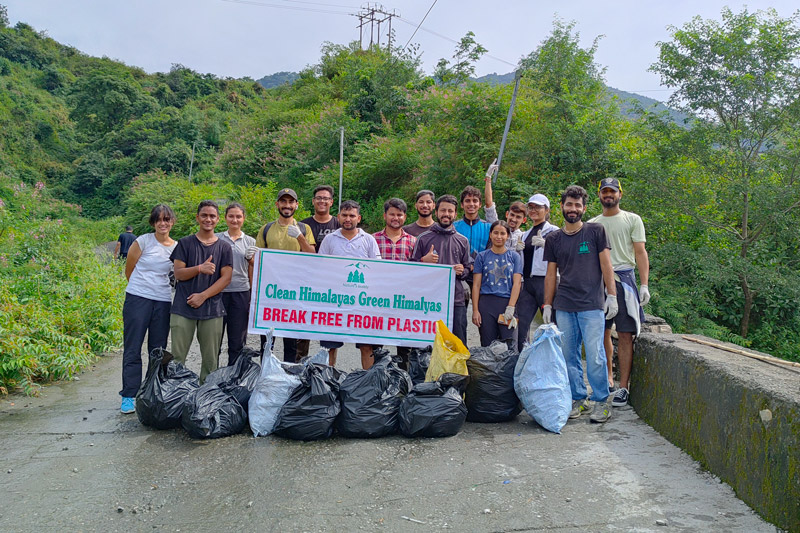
[{"xmin": 556, "ymin": 309, "xmax": 608, "ymax": 402}]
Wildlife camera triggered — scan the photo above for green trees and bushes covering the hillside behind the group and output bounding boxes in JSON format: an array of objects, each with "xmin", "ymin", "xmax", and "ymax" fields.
[{"xmin": 0, "ymin": 5, "xmax": 800, "ymax": 388}]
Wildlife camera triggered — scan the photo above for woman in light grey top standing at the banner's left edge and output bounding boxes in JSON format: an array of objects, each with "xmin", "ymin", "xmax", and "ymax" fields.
[{"xmin": 217, "ymin": 202, "xmax": 256, "ymax": 365}]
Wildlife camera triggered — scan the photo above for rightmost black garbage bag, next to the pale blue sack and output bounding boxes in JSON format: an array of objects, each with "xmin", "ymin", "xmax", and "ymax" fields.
[{"xmin": 464, "ymin": 341, "xmax": 522, "ymax": 422}]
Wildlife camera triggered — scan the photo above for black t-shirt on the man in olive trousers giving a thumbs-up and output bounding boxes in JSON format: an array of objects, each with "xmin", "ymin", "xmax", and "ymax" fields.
[{"xmin": 169, "ymin": 235, "xmax": 233, "ymax": 320}]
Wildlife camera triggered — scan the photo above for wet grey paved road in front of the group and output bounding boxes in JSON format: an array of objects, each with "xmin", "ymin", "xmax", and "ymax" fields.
[{"xmin": 0, "ymin": 332, "xmax": 775, "ymax": 533}]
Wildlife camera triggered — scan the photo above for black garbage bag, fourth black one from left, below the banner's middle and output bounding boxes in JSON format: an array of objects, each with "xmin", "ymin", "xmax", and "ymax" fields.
[{"xmin": 336, "ymin": 348, "xmax": 412, "ymax": 439}]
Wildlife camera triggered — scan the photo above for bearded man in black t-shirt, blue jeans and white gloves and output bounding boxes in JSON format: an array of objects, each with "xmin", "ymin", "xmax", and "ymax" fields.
[{"xmin": 542, "ymin": 185, "xmax": 618, "ymax": 423}]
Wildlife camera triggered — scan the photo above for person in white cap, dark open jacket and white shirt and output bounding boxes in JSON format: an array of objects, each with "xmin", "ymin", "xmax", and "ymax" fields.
[{"xmin": 517, "ymin": 194, "xmax": 558, "ymax": 350}]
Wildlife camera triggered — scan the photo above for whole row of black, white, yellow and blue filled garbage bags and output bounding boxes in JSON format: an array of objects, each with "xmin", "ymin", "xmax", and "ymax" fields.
[{"xmin": 136, "ymin": 322, "xmax": 572, "ymax": 441}]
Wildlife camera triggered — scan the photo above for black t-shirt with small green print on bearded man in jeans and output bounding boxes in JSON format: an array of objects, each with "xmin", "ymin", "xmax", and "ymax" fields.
[{"xmin": 544, "ymin": 222, "xmax": 611, "ymax": 313}]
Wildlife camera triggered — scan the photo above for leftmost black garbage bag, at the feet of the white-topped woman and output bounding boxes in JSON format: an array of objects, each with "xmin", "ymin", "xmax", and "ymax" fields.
[{"xmin": 136, "ymin": 348, "xmax": 200, "ymax": 429}]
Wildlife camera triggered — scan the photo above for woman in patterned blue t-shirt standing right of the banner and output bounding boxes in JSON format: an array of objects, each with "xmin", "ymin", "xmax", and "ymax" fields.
[{"xmin": 472, "ymin": 220, "xmax": 522, "ymax": 346}]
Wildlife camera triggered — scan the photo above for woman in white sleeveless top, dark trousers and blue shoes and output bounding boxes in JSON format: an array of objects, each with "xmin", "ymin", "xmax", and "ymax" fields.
[{"xmin": 119, "ymin": 204, "xmax": 177, "ymax": 414}]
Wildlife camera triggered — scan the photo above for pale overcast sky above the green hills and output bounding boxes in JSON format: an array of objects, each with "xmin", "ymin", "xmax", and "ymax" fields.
[{"xmin": 0, "ymin": 0, "xmax": 798, "ymax": 100}]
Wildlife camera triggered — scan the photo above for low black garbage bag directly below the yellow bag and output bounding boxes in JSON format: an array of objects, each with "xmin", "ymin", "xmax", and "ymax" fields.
[{"xmin": 398, "ymin": 373, "xmax": 470, "ymax": 437}]
